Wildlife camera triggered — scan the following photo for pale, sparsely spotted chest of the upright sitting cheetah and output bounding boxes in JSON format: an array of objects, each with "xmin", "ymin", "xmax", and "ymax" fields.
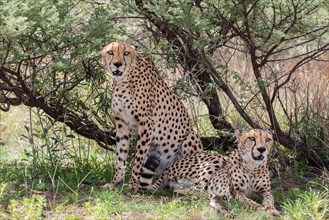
[{"xmin": 112, "ymin": 90, "xmax": 138, "ymax": 131}]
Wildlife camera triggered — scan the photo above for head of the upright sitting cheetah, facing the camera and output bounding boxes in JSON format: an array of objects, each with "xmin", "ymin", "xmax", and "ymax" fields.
[{"xmin": 101, "ymin": 42, "xmax": 137, "ymax": 81}]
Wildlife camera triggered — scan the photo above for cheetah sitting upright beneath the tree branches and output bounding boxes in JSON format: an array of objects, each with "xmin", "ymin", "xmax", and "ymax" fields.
[{"xmin": 101, "ymin": 42, "xmax": 202, "ymax": 190}]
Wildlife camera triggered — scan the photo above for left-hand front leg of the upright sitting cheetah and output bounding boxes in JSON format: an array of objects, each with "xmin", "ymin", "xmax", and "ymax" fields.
[{"xmin": 103, "ymin": 116, "xmax": 130, "ymax": 187}]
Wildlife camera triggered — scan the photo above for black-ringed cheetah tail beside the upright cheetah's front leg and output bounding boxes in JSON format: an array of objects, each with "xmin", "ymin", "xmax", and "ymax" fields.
[{"xmin": 139, "ymin": 154, "xmax": 161, "ymax": 189}]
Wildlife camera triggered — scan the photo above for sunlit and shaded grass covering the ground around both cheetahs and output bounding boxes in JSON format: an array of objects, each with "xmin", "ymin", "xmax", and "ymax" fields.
[{"xmin": 0, "ymin": 106, "xmax": 329, "ymax": 220}]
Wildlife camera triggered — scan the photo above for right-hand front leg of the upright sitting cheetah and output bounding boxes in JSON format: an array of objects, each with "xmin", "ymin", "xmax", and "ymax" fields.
[{"xmin": 128, "ymin": 119, "xmax": 151, "ymax": 191}]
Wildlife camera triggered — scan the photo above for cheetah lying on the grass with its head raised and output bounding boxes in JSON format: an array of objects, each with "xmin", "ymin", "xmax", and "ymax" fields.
[{"xmin": 145, "ymin": 129, "xmax": 279, "ymax": 215}]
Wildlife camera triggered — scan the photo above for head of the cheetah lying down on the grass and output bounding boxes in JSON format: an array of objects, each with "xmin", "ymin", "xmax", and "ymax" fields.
[{"xmin": 235, "ymin": 129, "xmax": 273, "ymax": 167}]
